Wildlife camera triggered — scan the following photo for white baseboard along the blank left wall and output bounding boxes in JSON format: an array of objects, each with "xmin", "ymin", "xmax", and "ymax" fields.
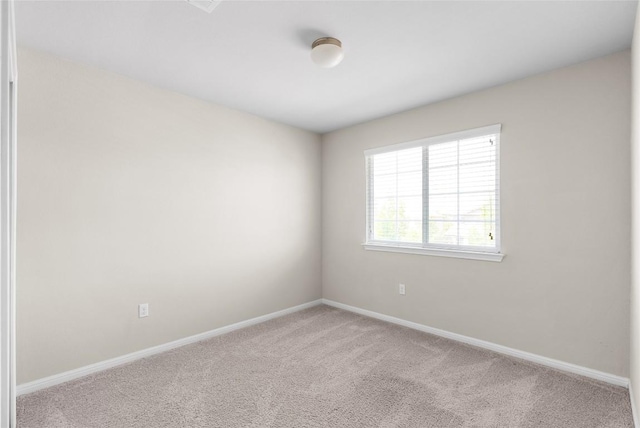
[{"xmin": 17, "ymin": 299, "xmax": 322, "ymax": 395}]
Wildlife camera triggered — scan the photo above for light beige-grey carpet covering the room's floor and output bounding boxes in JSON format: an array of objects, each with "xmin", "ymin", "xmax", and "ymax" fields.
[{"xmin": 18, "ymin": 306, "xmax": 633, "ymax": 428}]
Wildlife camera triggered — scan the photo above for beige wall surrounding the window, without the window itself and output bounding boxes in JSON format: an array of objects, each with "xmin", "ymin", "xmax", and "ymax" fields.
[{"xmin": 323, "ymin": 51, "xmax": 630, "ymax": 376}]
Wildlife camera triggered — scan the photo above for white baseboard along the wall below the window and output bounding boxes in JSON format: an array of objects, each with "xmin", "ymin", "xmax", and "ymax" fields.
[{"xmin": 322, "ymin": 299, "xmax": 640, "ymax": 388}]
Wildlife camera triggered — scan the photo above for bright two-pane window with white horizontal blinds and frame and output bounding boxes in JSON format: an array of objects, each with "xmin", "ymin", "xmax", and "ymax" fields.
[{"xmin": 364, "ymin": 125, "xmax": 502, "ymax": 261}]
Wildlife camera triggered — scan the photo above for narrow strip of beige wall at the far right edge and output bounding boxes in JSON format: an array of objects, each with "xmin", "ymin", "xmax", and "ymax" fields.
[{"xmin": 631, "ymin": 8, "xmax": 640, "ymax": 417}]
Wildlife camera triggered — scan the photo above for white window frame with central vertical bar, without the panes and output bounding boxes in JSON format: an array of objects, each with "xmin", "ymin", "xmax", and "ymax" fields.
[{"xmin": 362, "ymin": 124, "xmax": 504, "ymax": 262}]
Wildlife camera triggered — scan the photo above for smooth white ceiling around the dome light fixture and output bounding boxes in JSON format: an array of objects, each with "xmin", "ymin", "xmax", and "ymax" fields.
[{"xmin": 16, "ymin": 0, "xmax": 637, "ymax": 132}]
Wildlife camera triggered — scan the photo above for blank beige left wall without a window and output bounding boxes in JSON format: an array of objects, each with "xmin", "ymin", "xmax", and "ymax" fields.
[{"xmin": 17, "ymin": 49, "xmax": 321, "ymax": 383}]
